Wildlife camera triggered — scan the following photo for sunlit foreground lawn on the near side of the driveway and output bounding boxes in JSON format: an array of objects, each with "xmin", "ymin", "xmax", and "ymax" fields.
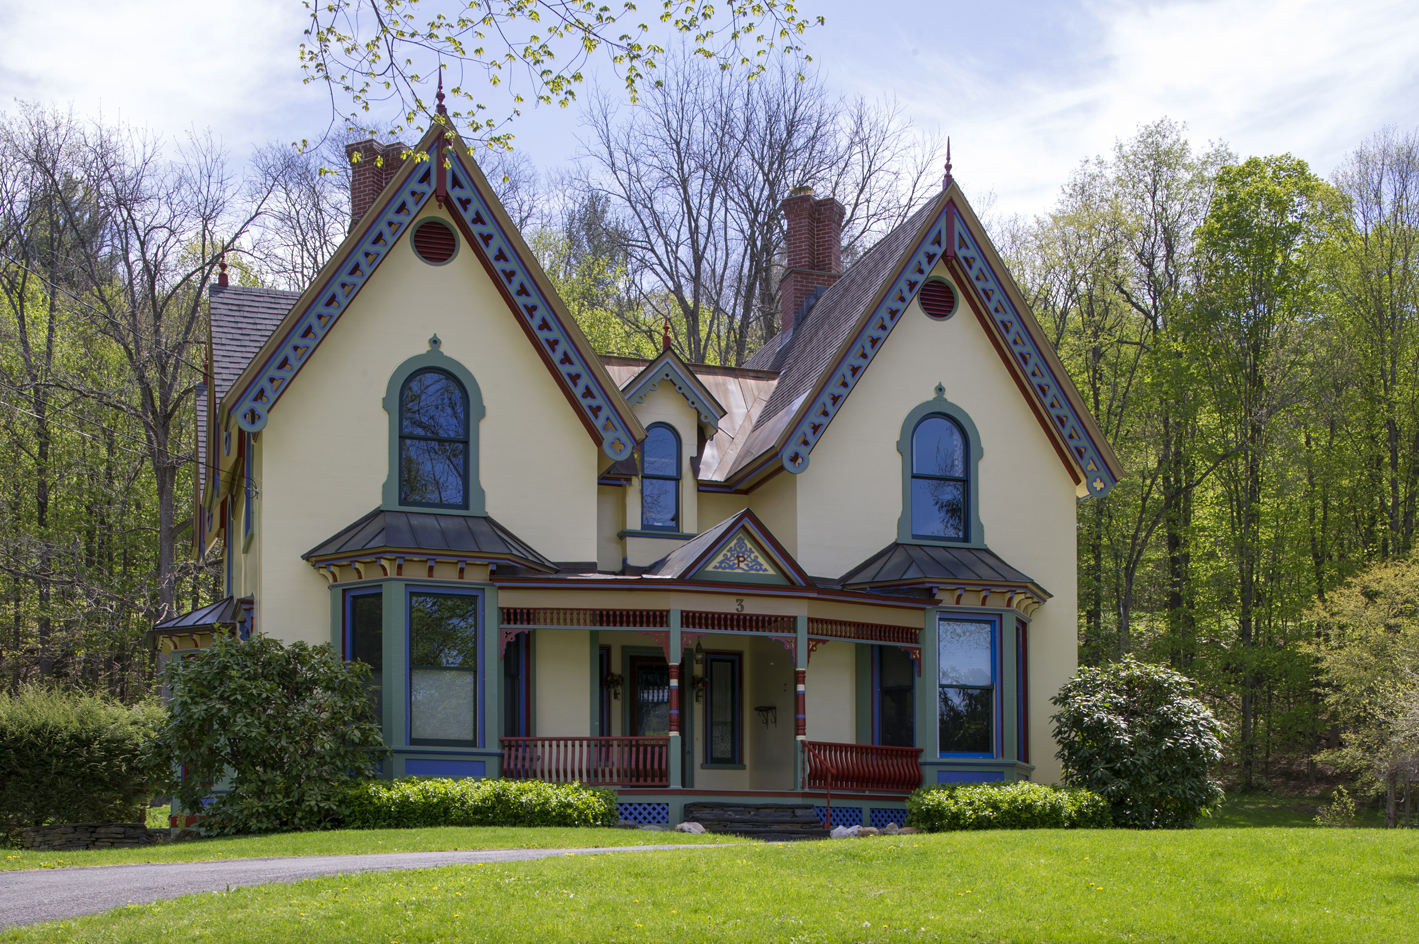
[{"xmin": 0, "ymin": 829, "xmax": 1419, "ymax": 944}]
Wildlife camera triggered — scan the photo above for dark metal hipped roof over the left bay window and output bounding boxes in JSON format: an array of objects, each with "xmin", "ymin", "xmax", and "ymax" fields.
[{"xmin": 301, "ymin": 508, "xmax": 558, "ymax": 572}]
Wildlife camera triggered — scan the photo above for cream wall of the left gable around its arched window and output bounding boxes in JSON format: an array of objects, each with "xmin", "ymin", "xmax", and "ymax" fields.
[{"xmin": 252, "ymin": 202, "xmax": 597, "ymax": 642}]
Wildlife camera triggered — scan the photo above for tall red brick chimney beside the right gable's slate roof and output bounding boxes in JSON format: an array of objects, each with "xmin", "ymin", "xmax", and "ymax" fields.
[{"xmin": 779, "ymin": 187, "xmax": 847, "ymax": 331}]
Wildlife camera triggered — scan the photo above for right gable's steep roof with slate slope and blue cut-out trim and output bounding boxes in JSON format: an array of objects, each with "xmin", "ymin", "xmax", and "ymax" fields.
[{"xmin": 727, "ymin": 182, "xmax": 1122, "ymax": 495}]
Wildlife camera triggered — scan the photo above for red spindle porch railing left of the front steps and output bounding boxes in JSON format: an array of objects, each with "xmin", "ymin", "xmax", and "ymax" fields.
[{"xmin": 502, "ymin": 738, "xmax": 670, "ymax": 786}]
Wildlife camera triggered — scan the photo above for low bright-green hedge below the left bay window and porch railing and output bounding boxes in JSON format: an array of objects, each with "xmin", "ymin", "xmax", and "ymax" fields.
[{"xmin": 341, "ymin": 776, "xmax": 617, "ymax": 829}]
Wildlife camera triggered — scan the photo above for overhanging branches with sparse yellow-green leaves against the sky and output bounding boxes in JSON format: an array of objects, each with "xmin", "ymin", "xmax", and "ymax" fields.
[{"xmin": 301, "ymin": 0, "xmax": 823, "ymax": 146}]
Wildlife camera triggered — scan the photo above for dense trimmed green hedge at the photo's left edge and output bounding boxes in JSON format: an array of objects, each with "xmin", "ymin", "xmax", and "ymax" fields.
[{"xmin": 0, "ymin": 688, "xmax": 163, "ymax": 843}]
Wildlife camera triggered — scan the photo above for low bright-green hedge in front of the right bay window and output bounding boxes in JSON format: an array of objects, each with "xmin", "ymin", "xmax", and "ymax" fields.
[{"xmin": 907, "ymin": 781, "xmax": 1114, "ymax": 832}]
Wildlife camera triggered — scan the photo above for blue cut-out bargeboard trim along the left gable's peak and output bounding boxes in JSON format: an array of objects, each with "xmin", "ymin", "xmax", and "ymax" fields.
[{"xmin": 221, "ymin": 125, "xmax": 646, "ymax": 460}]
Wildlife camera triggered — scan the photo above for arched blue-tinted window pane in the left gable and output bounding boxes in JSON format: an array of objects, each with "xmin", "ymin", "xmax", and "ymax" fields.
[{"xmin": 399, "ymin": 368, "xmax": 468, "ymax": 508}]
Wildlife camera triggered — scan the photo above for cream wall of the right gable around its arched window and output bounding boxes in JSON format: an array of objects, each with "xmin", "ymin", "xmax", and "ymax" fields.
[{"xmin": 800, "ymin": 261, "xmax": 1077, "ymax": 782}]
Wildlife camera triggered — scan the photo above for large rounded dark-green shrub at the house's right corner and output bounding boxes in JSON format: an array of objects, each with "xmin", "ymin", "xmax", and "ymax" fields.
[{"xmin": 1053, "ymin": 659, "xmax": 1223, "ymax": 829}]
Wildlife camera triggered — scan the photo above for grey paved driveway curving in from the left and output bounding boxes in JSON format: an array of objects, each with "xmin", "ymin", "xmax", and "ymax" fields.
[{"xmin": 0, "ymin": 845, "xmax": 709, "ymax": 927}]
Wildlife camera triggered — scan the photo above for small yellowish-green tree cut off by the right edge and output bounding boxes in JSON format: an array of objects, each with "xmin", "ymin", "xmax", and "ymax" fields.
[{"xmin": 1310, "ymin": 558, "xmax": 1419, "ymax": 826}]
